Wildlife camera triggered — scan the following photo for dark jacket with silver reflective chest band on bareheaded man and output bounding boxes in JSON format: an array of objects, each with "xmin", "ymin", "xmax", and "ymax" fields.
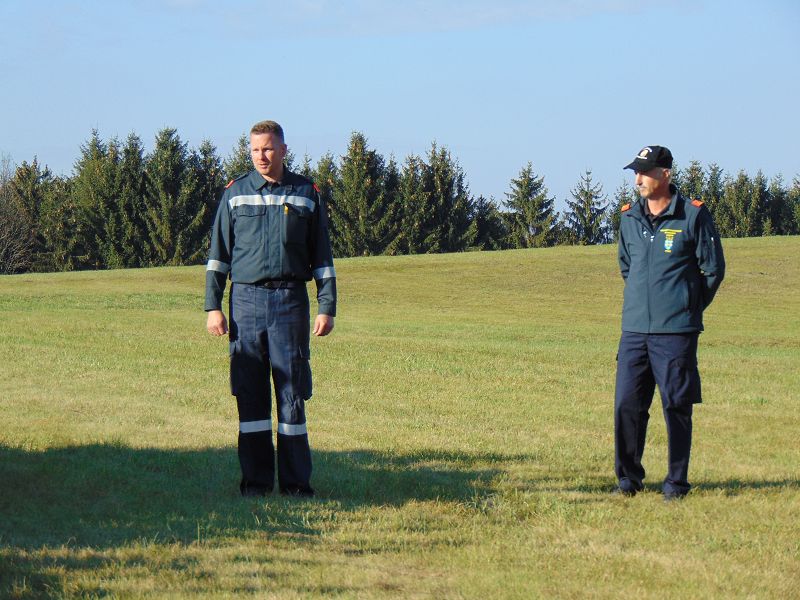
[{"xmin": 205, "ymin": 169, "xmax": 336, "ymax": 316}]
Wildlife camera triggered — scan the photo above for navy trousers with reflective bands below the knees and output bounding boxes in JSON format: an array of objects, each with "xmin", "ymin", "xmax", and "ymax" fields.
[{"xmin": 230, "ymin": 282, "xmax": 311, "ymax": 495}]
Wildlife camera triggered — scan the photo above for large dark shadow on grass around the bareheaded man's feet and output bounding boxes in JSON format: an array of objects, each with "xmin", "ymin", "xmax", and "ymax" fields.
[{"xmin": 0, "ymin": 444, "xmax": 528, "ymax": 549}]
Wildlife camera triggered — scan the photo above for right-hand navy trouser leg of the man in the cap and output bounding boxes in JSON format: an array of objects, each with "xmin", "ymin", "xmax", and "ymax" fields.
[{"xmin": 647, "ymin": 333, "xmax": 701, "ymax": 494}]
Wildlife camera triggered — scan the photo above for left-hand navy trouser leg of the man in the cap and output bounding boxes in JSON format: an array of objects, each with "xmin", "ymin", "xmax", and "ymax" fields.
[{"xmin": 614, "ymin": 332, "xmax": 655, "ymax": 489}]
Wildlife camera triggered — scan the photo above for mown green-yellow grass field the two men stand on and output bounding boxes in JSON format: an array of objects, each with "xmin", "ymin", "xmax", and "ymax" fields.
[{"xmin": 0, "ymin": 237, "xmax": 800, "ymax": 598}]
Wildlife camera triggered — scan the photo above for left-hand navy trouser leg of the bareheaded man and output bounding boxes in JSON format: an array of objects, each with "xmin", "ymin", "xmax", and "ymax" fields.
[{"xmin": 230, "ymin": 284, "xmax": 275, "ymax": 493}]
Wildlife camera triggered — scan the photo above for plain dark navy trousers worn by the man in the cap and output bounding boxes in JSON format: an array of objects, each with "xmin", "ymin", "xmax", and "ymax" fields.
[{"xmin": 614, "ymin": 331, "xmax": 701, "ymax": 494}]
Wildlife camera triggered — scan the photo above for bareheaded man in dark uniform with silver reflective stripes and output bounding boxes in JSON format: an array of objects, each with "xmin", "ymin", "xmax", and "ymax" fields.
[{"xmin": 205, "ymin": 121, "xmax": 336, "ymax": 497}]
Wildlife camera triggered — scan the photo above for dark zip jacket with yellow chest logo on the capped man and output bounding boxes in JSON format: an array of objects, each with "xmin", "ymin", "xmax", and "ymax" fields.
[{"xmin": 618, "ymin": 186, "xmax": 725, "ymax": 333}]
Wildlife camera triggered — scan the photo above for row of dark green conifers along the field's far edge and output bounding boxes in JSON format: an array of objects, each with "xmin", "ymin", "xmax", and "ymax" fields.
[{"xmin": 0, "ymin": 128, "xmax": 800, "ymax": 273}]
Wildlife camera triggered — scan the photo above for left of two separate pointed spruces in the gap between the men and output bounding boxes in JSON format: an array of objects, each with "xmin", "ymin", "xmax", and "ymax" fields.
[{"xmin": 506, "ymin": 162, "xmax": 556, "ymax": 248}]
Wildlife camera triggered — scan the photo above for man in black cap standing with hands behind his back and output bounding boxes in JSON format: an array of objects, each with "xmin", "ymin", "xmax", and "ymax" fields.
[{"xmin": 614, "ymin": 146, "xmax": 725, "ymax": 501}]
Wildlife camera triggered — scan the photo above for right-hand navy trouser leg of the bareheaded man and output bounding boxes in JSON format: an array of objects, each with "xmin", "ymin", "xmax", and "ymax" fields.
[{"xmin": 267, "ymin": 287, "xmax": 311, "ymax": 491}]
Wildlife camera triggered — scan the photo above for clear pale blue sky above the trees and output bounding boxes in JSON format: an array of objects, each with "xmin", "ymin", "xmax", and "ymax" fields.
[{"xmin": 0, "ymin": 0, "xmax": 800, "ymax": 208}]
